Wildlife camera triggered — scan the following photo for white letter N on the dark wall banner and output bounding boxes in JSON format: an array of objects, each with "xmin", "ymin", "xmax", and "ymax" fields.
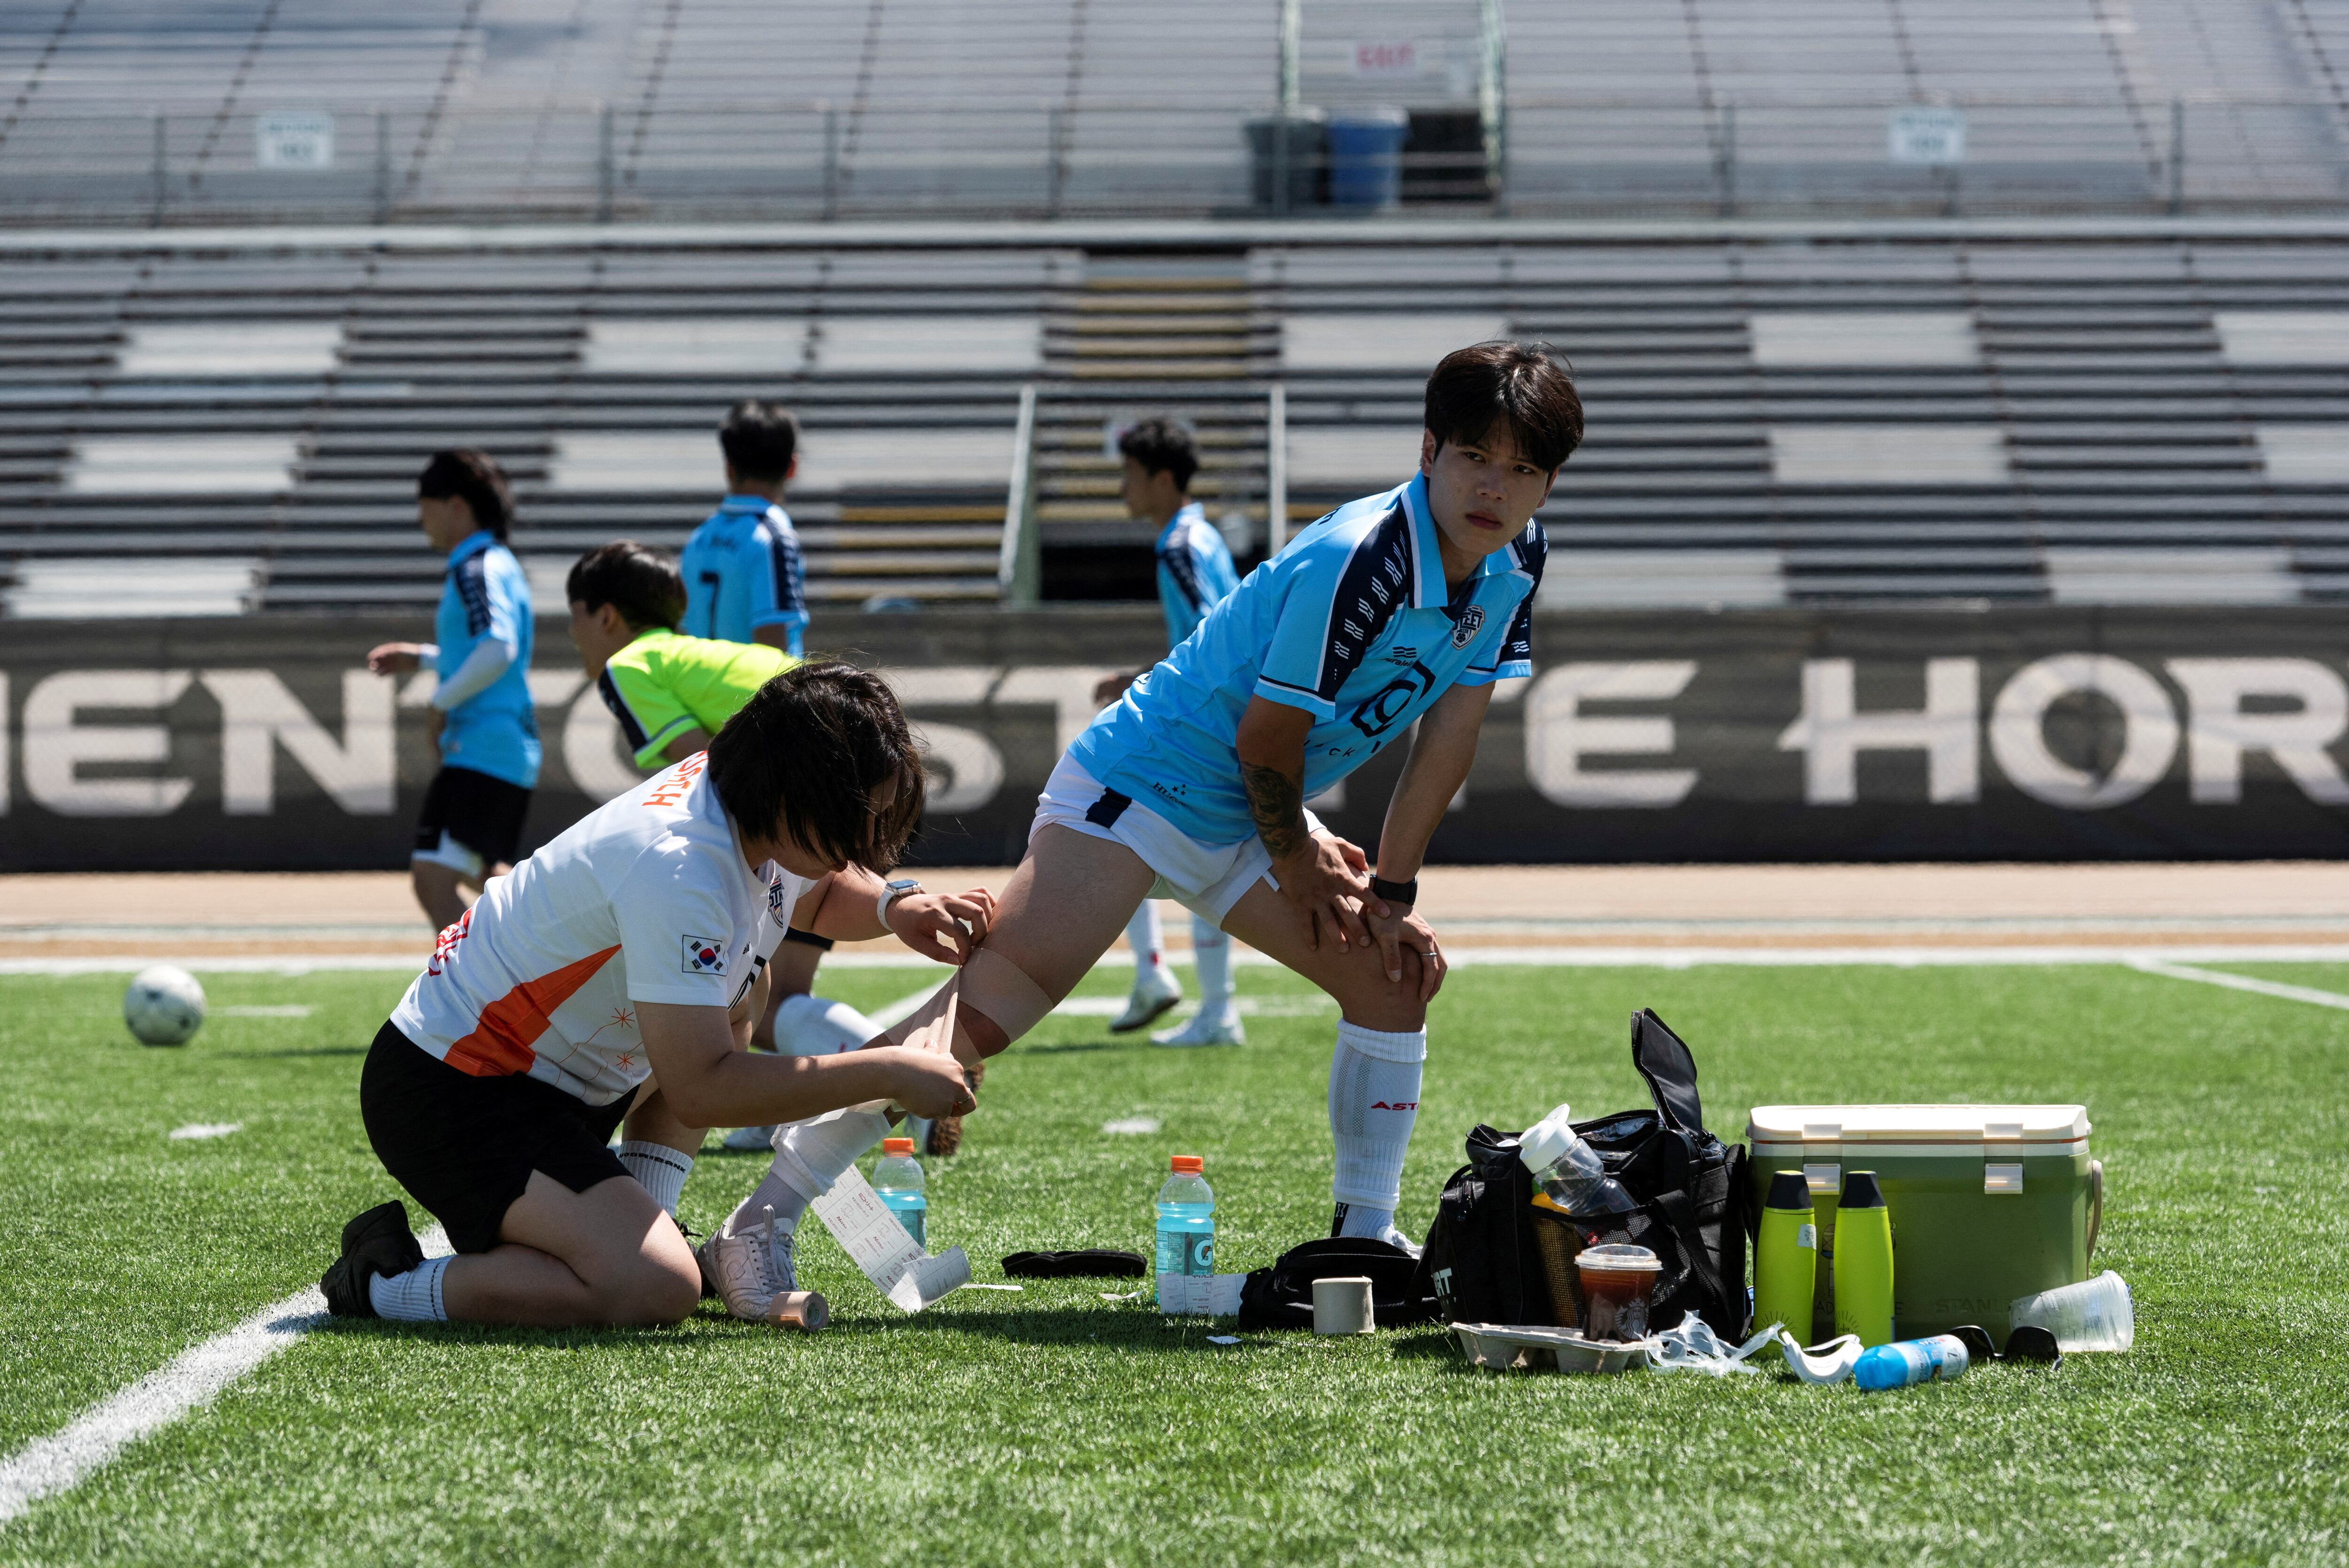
[{"xmin": 204, "ymin": 669, "xmax": 397, "ymax": 817}]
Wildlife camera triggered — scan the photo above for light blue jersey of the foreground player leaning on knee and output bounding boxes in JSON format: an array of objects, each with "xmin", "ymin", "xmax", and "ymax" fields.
[{"xmin": 1069, "ymin": 479, "xmax": 1548, "ymax": 845}]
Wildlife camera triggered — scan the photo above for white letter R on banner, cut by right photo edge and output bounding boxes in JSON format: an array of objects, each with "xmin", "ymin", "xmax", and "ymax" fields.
[{"xmin": 2168, "ymin": 660, "xmax": 2349, "ymax": 805}]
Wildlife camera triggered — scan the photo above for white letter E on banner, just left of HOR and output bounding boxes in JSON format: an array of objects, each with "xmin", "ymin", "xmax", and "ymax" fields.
[{"xmin": 1525, "ymin": 660, "xmax": 1696, "ymax": 807}]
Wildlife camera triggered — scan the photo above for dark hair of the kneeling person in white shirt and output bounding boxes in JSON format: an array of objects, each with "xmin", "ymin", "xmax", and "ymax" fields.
[{"xmin": 709, "ymin": 660, "xmax": 923, "ymax": 871}]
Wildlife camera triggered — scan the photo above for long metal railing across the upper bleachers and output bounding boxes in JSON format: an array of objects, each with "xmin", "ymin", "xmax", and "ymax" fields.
[{"xmin": 0, "ymin": 94, "xmax": 2349, "ymax": 225}]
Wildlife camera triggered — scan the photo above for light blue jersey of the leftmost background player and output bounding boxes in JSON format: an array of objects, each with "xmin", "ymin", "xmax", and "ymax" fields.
[{"xmin": 432, "ymin": 528, "xmax": 538, "ymax": 789}]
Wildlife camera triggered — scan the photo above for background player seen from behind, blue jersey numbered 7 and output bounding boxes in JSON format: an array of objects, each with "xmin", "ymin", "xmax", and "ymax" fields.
[{"xmin": 679, "ymin": 399, "xmax": 808, "ymax": 655}]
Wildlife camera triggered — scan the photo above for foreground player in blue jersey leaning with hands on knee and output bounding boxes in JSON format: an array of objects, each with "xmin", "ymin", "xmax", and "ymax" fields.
[{"xmin": 752, "ymin": 343, "xmax": 1583, "ymax": 1246}]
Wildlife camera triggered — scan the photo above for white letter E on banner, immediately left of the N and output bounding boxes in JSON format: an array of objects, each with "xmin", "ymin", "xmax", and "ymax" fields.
[{"xmin": 23, "ymin": 669, "xmax": 195, "ymax": 817}]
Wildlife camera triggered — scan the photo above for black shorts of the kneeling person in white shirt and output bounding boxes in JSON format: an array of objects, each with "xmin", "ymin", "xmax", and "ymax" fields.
[{"xmin": 359, "ymin": 1024, "xmax": 637, "ymax": 1251}]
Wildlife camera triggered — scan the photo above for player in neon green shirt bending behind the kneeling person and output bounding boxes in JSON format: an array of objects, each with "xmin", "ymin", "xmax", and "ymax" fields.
[{"xmin": 564, "ymin": 540, "xmax": 994, "ymax": 1155}]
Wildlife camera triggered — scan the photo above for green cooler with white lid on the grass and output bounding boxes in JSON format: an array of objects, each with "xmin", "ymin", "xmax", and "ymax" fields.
[{"xmin": 1745, "ymin": 1106, "xmax": 2105, "ymax": 1345}]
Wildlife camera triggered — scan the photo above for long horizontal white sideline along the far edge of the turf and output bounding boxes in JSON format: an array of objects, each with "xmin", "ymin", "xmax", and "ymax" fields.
[{"xmin": 32, "ymin": 941, "xmax": 2349, "ymax": 981}]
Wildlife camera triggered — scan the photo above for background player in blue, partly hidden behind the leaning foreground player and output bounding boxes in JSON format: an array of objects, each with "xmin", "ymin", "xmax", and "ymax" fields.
[{"xmin": 1092, "ymin": 418, "xmax": 1247, "ymax": 1045}]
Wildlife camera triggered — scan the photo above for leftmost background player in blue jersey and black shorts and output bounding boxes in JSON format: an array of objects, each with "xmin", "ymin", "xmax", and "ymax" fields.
[{"xmin": 366, "ymin": 448, "xmax": 538, "ymax": 927}]
